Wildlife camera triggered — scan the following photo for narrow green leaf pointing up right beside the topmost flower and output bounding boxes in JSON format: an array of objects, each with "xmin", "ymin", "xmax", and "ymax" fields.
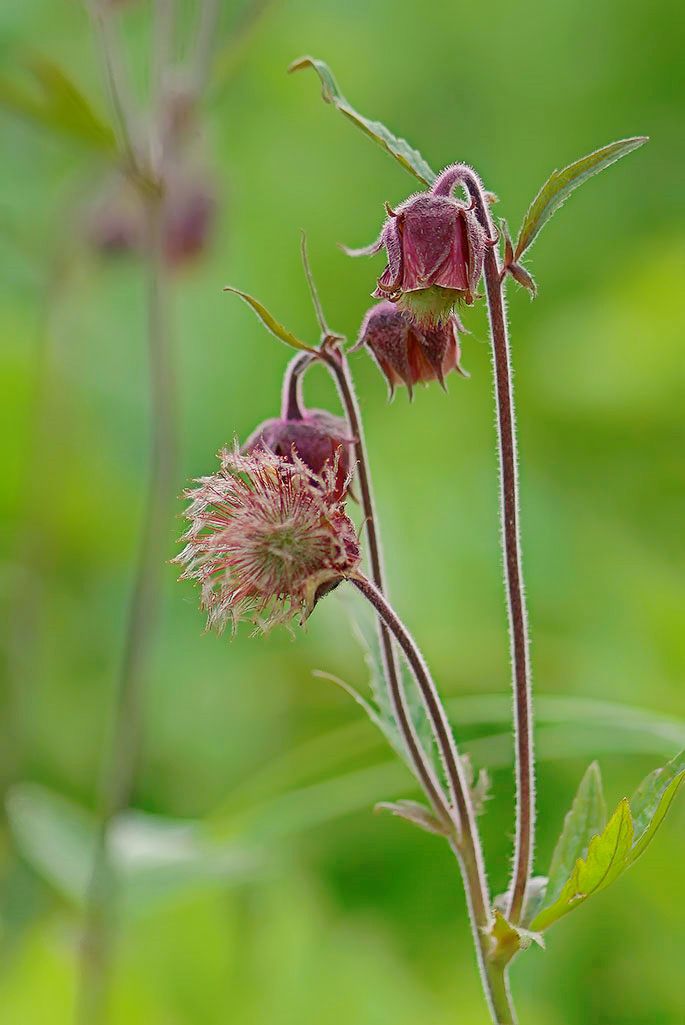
[{"xmin": 514, "ymin": 135, "xmax": 647, "ymax": 260}]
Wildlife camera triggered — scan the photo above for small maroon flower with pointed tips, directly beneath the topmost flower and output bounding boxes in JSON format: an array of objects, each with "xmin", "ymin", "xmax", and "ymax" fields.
[{"xmin": 351, "ymin": 300, "xmax": 468, "ymax": 398}]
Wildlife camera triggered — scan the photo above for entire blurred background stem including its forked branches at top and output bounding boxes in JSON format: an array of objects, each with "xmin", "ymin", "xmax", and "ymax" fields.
[{"xmin": 76, "ymin": 6, "xmax": 176, "ymax": 1025}]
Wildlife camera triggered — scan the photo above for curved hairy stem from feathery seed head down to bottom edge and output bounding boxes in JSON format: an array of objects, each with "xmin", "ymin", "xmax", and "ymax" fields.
[{"xmin": 350, "ymin": 575, "xmax": 516, "ymax": 1025}]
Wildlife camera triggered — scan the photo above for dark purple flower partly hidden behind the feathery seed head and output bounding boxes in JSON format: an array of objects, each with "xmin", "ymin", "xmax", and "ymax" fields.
[{"xmin": 243, "ymin": 409, "xmax": 353, "ymax": 500}]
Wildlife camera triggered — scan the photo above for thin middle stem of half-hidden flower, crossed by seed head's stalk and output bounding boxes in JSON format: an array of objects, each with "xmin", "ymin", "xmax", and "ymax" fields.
[{"xmin": 321, "ymin": 342, "xmax": 454, "ymax": 822}]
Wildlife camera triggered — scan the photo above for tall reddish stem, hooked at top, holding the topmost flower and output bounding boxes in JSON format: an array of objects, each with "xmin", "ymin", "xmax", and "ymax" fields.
[{"xmin": 433, "ymin": 164, "xmax": 535, "ymax": 925}]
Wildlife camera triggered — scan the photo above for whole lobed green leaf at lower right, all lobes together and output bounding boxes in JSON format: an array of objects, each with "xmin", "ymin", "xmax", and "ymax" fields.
[{"xmin": 531, "ymin": 752, "xmax": 685, "ymax": 931}]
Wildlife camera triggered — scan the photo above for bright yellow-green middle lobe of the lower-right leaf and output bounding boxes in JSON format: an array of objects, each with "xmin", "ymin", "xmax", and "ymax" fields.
[{"xmin": 531, "ymin": 797, "xmax": 633, "ymax": 932}]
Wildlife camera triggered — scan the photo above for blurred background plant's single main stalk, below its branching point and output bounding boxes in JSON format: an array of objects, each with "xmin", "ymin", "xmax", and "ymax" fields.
[{"xmin": 77, "ymin": 193, "xmax": 176, "ymax": 1025}]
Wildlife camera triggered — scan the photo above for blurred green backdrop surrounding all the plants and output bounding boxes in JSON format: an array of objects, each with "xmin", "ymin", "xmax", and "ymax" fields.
[{"xmin": 0, "ymin": 0, "xmax": 685, "ymax": 1025}]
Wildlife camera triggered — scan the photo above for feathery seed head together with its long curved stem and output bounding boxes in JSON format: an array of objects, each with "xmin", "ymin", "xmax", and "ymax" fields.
[{"xmin": 174, "ymin": 436, "xmax": 514, "ymax": 1025}]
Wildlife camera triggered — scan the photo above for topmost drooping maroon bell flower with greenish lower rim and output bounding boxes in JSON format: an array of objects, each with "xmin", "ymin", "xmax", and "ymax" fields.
[{"xmin": 347, "ymin": 175, "xmax": 488, "ymax": 325}]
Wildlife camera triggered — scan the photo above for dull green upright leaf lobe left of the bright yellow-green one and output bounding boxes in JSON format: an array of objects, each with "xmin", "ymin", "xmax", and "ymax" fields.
[{"xmin": 546, "ymin": 762, "xmax": 606, "ymax": 904}]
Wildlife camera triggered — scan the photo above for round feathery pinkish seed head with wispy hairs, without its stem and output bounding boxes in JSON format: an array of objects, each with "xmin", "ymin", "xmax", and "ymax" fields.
[{"xmin": 174, "ymin": 447, "xmax": 360, "ymax": 632}]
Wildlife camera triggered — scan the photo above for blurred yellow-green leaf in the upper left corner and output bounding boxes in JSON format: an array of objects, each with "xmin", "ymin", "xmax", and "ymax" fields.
[{"xmin": 0, "ymin": 57, "xmax": 117, "ymax": 153}]
